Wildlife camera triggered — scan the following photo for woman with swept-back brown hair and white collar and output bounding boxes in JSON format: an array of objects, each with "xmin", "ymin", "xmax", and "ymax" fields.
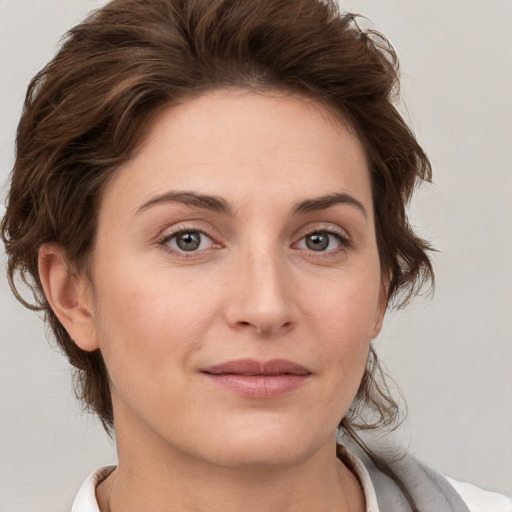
[{"xmin": 2, "ymin": 0, "xmax": 510, "ymax": 512}]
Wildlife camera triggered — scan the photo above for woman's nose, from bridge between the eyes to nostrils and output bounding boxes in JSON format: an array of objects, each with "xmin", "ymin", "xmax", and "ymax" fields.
[{"xmin": 225, "ymin": 246, "xmax": 298, "ymax": 337}]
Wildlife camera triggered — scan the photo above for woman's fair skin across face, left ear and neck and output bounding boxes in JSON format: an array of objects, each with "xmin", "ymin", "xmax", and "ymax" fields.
[{"xmin": 40, "ymin": 90, "xmax": 386, "ymax": 512}]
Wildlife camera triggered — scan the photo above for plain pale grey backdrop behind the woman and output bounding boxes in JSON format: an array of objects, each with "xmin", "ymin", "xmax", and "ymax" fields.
[{"xmin": 0, "ymin": 0, "xmax": 512, "ymax": 512}]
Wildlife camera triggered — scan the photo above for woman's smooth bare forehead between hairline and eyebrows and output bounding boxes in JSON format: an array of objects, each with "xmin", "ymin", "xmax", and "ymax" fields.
[{"xmin": 99, "ymin": 89, "xmax": 371, "ymax": 218}]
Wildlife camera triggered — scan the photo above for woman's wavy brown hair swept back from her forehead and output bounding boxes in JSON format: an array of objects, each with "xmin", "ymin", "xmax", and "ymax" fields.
[{"xmin": 1, "ymin": 0, "xmax": 433, "ymax": 486}]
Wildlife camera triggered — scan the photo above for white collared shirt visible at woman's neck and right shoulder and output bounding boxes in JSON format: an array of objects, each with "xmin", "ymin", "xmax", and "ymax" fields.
[{"xmin": 71, "ymin": 453, "xmax": 512, "ymax": 512}]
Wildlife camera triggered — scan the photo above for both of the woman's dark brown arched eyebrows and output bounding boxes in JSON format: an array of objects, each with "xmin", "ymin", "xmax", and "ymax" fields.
[{"xmin": 136, "ymin": 191, "xmax": 368, "ymax": 219}]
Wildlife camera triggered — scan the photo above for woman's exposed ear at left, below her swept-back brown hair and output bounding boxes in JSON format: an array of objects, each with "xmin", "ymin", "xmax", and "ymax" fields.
[{"xmin": 38, "ymin": 244, "xmax": 99, "ymax": 352}]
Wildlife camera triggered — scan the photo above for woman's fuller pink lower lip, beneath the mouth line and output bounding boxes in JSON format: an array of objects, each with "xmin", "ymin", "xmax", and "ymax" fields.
[{"xmin": 205, "ymin": 373, "xmax": 309, "ymax": 399}]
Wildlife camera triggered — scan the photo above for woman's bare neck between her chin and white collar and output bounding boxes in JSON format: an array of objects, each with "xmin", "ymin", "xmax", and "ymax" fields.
[{"xmin": 97, "ymin": 410, "xmax": 365, "ymax": 512}]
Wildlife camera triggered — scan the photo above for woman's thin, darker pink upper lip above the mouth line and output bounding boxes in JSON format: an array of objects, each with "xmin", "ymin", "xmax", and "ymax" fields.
[{"xmin": 202, "ymin": 359, "xmax": 311, "ymax": 376}]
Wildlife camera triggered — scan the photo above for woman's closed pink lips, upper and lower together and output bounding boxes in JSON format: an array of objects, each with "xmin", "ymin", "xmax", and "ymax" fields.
[{"xmin": 202, "ymin": 359, "xmax": 311, "ymax": 399}]
